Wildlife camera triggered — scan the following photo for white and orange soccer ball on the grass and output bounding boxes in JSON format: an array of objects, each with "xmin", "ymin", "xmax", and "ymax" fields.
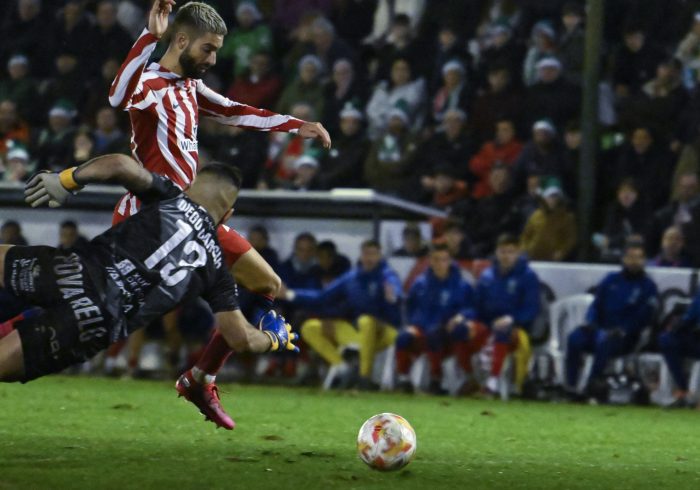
[{"xmin": 357, "ymin": 413, "xmax": 416, "ymax": 471}]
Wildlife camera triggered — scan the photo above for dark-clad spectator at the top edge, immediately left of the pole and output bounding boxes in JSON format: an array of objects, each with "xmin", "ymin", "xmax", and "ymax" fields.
[{"xmin": 558, "ymin": 2, "xmax": 585, "ymax": 84}]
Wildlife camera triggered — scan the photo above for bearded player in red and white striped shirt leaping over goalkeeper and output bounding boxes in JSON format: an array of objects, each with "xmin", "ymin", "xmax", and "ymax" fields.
[{"xmin": 109, "ymin": 0, "xmax": 331, "ymax": 429}]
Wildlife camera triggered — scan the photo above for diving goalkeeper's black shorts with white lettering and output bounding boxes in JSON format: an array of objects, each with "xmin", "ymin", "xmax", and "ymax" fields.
[{"xmin": 5, "ymin": 247, "xmax": 113, "ymax": 381}]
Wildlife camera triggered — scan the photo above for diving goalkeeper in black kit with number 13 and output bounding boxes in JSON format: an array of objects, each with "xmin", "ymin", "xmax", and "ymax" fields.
[{"xmin": 0, "ymin": 155, "xmax": 296, "ymax": 428}]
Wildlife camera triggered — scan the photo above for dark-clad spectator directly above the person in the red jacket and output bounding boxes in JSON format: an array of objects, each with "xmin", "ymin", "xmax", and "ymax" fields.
[{"xmin": 469, "ymin": 65, "xmax": 523, "ymax": 144}]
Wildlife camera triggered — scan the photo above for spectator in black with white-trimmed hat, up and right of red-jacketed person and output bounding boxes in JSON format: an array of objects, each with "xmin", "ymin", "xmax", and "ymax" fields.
[{"xmin": 525, "ymin": 58, "xmax": 581, "ymax": 130}]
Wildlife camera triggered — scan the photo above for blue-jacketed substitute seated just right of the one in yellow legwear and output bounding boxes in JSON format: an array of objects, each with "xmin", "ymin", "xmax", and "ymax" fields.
[{"xmin": 396, "ymin": 245, "xmax": 474, "ymax": 394}]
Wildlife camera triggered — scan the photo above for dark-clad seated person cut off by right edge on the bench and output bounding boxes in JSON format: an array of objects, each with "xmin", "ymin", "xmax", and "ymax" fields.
[{"xmin": 659, "ymin": 294, "xmax": 700, "ymax": 407}]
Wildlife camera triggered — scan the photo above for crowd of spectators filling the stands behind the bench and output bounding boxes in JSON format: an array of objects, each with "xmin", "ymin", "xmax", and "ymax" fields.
[{"xmin": 0, "ymin": 0, "xmax": 700, "ymax": 266}]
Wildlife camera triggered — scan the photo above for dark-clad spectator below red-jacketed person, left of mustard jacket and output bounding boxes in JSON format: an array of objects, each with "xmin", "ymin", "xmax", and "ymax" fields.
[{"xmin": 465, "ymin": 163, "xmax": 515, "ymax": 257}]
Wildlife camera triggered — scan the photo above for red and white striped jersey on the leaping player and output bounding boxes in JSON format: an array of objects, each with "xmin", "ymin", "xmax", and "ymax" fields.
[{"xmin": 109, "ymin": 29, "xmax": 304, "ymax": 189}]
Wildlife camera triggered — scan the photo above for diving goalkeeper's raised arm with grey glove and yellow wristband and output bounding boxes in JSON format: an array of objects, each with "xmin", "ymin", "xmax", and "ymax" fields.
[{"xmin": 24, "ymin": 154, "xmax": 153, "ymax": 208}]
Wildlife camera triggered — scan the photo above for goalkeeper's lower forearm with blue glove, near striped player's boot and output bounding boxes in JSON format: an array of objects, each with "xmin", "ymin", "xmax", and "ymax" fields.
[{"xmin": 216, "ymin": 310, "xmax": 299, "ymax": 353}]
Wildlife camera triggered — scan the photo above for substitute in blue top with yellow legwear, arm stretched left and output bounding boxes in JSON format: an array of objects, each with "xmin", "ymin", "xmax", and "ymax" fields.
[{"xmin": 281, "ymin": 240, "xmax": 403, "ymax": 389}]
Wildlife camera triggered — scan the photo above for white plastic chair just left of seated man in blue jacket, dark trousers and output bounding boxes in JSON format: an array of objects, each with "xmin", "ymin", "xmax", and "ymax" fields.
[{"xmin": 548, "ymin": 294, "xmax": 594, "ymax": 385}]
